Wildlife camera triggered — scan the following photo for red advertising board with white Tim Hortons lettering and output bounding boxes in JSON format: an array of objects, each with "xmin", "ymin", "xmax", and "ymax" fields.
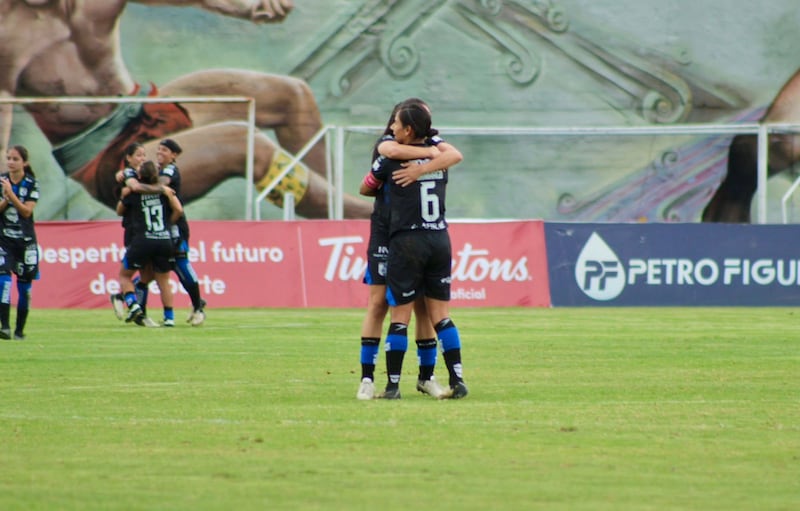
[{"xmin": 33, "ymin": 220, "xmax": 550, "ymax": 308}]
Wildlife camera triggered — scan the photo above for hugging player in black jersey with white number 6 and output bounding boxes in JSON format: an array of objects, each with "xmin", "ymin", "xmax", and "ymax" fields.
[{"xmin": 365, "ymin": 104, "xmax": 467, "ymax": 399}]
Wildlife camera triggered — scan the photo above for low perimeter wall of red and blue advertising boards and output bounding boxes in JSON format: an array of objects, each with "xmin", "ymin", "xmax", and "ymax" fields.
[{"xmin": 33, "ymin": 220, "xmax": 800, "ymax": 309}]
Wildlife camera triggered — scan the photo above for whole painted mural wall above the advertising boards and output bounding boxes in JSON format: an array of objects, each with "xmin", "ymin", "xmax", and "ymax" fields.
[{"xmin": 0, "ymin": 0, "xmax": 800, "ymax": 222}]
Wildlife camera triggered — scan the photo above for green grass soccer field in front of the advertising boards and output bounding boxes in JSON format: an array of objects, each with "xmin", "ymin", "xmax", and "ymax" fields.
[{"xmin": 0, "ymin": 308, "xmax": 800, "ymax": 511}]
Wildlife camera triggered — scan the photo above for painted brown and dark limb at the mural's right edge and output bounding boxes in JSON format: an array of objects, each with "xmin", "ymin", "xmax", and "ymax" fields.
[{"xmin": 703, "ymin": 67, "xmax": 800, "ymax": 223}]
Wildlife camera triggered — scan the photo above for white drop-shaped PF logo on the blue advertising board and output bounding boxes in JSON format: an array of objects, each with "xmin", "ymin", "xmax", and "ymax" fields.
[{"xmin": 575, "ymin": 232, "xmax": 625, "ymax": 301}]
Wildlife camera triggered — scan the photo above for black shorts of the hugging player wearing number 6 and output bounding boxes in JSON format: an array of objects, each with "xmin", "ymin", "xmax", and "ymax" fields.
[{"xmin": 386, "ymin": 231, "xmax": 453, "ymax": 305}]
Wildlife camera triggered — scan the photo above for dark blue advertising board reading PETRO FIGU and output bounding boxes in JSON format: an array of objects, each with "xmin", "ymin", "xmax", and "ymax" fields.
[{"xmin": 545, "ymin": 222, "xmax": 800, "ymax": 306}]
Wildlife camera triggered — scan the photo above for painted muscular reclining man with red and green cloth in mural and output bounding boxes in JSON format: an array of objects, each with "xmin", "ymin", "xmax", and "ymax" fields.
[{"xmin": 0, "ymin": 0, "xmax": 372, "ymax": 218}]
